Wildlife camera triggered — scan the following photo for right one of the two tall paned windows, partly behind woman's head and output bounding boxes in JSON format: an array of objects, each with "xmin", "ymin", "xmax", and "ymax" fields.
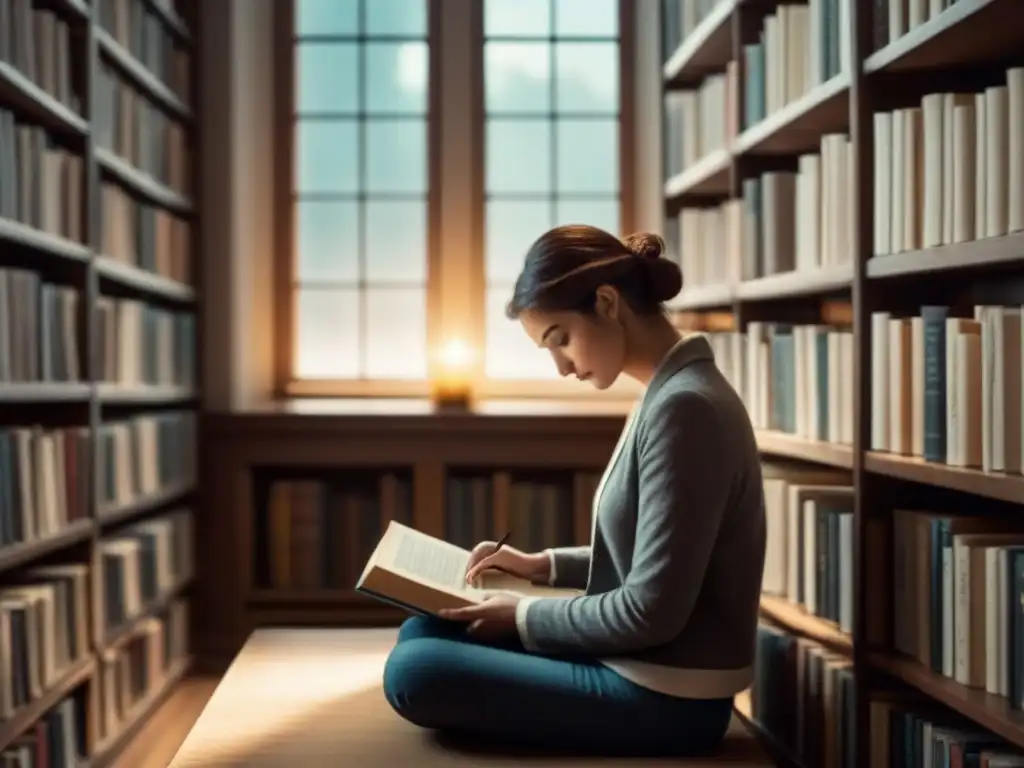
[{"xmin": 483, "ymin": 0, "xmax": 621, "ymax": 380}]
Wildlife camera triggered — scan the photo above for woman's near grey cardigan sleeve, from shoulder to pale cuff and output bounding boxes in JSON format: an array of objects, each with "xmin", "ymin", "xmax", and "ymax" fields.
[{"xmin": 516, "ymin": 391, "xmax": 733, "ymax": 654}]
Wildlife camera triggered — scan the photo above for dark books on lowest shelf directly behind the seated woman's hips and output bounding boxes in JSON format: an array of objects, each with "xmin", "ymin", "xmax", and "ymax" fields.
[{"xmin": 751, "ymin": 622, "xmax": 851, "ymax": 768}]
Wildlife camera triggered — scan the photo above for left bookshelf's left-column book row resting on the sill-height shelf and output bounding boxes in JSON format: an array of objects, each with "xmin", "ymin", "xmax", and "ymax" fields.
[{"xmin": 0, "ymin": 267, "xmax": 82, "ymax": 383}]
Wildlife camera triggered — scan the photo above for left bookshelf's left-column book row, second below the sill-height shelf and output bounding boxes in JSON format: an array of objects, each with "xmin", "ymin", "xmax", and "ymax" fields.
[{"xmin": 0, "ymin": 564, "xmax": 91, "ymax": 721}]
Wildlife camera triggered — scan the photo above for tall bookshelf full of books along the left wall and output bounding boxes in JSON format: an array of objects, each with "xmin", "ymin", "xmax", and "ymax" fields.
[{"xmin": 0, "ymin": 0, "xmax": 200, "ymax": 768}]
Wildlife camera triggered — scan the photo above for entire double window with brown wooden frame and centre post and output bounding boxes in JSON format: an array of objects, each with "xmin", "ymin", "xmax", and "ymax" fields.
[{"xmin": 278, "ymin": 0, "xmax": 632, "ymax": 395}]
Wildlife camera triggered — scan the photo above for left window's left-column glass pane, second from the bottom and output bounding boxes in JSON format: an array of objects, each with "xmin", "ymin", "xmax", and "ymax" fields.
[{"xmin": 295, "ymin": 201, "xmax": 359, "ymax": 283}]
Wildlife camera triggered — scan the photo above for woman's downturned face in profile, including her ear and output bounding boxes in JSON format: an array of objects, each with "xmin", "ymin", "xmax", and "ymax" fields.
[{"xmin": 519, "ymin": 288, "xmax": 626, "ymax": 389}]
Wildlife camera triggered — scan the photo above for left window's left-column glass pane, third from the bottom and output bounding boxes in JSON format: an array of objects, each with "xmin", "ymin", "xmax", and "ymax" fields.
[{"xmin": 295, "ymin": 120, "xmax": 359, "ymax": 193}]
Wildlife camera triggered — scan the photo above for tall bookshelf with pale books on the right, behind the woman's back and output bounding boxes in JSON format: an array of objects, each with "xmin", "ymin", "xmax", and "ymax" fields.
[{"xmin": 663, "ymin": 0, "xmax": 1024, "ymax": 768}]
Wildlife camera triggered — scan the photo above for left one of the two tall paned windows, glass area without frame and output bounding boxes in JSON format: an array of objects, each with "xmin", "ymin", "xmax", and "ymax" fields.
[{"xmin": 291, "ymin": 0, "xmax": 429, "ymax": 380}]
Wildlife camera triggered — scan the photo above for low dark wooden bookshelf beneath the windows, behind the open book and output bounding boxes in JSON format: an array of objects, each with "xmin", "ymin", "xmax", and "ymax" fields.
[{"xmin": 194, "ymin": 398, "xmax": 629, "ymax": 669}]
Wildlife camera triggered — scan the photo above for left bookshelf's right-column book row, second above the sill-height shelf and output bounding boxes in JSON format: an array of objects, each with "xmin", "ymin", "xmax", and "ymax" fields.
[{"xmin": 99, "ymin": 183, "xmax": 193, "ymax": 285}]
